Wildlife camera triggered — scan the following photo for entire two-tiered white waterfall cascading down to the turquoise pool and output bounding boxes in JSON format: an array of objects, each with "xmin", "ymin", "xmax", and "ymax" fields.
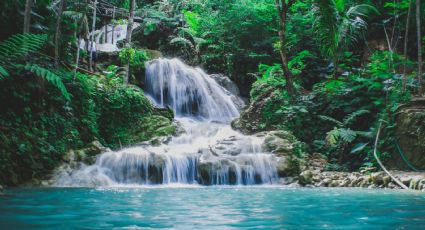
[{"xmin": 55, "ymin": 59, "xmax": 278, "ymax": 186}]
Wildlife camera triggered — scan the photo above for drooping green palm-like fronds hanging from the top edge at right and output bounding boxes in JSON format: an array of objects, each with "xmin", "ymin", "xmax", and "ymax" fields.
[{"xmin": 313, "ymin": 0, "xmax": 378, "ymax": 77}]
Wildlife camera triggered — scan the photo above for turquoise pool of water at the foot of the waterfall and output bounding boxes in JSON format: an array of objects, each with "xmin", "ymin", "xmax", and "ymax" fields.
[{"xmin": 0, "ymin": 186, "xmax": 425, "ymax": 229}]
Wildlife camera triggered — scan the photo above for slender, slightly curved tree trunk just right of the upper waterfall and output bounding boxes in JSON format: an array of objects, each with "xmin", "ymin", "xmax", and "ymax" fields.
[{"xmin": 276, "ymin": 0, "xmax": 295, "ymax": 97}]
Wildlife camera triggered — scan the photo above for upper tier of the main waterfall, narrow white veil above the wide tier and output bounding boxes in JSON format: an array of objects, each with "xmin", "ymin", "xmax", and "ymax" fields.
[{"xmin": 145, "ymin": 58, "xmax": 239, "ymax": 122}]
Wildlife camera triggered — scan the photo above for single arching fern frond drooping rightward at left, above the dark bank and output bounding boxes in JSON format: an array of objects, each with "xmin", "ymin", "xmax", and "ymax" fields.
[{"xmin": 24, "ymin": 64, "xmax": 71, "ymax": 100}]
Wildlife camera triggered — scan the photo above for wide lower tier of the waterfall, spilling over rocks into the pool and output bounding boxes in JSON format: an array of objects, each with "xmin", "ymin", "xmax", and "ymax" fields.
[{"xmin": 55, "ymin": 119, "xmax": 278, "ymax": 187}]
